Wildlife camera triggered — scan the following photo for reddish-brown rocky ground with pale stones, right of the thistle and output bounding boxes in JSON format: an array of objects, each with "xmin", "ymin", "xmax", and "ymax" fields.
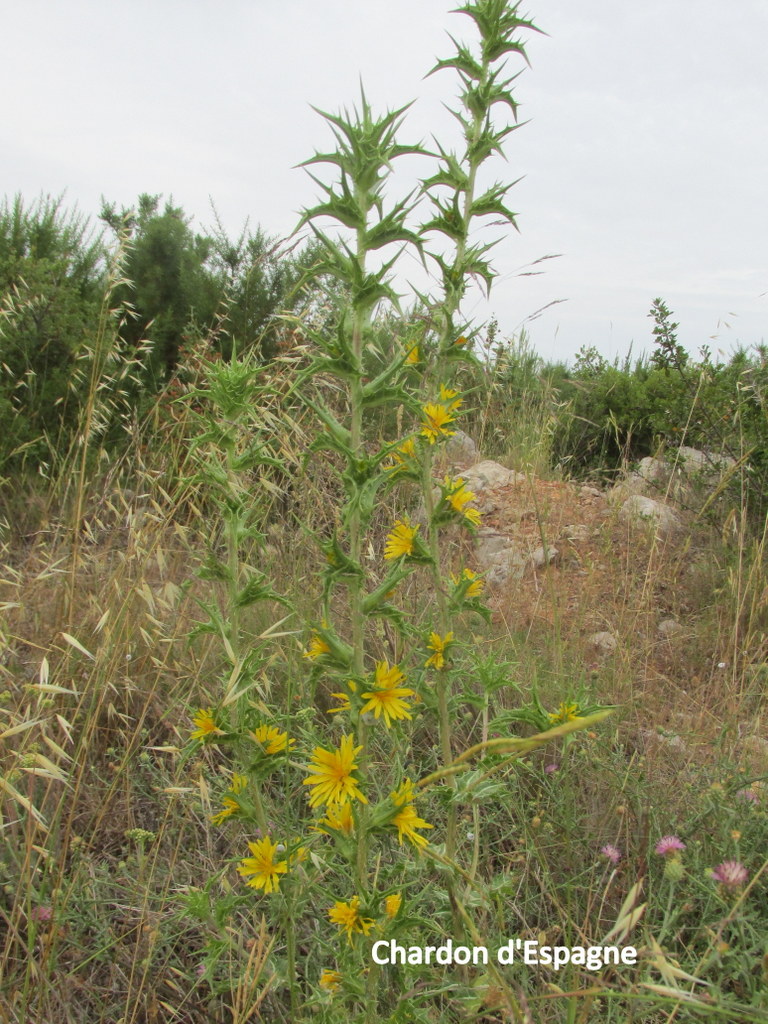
[{"xmin": 438, "ymin": 435, "xmax": 768, "ymax": 771}]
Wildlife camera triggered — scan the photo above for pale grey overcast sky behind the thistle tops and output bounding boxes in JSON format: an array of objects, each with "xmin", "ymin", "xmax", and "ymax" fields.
[{"xmin": 0, "ymin": 0, "xmax": 768, "ymax": 359}]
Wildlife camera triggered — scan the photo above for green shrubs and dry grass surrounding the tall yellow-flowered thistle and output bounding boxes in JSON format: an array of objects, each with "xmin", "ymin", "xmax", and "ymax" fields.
[{"xmin": 0, "ymin": 4, "xmax": 768, "ymax": 1024}]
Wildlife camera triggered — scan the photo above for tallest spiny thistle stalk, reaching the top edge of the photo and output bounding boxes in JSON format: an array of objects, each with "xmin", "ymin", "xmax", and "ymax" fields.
[{"xmin": 421, "ymin": 0, "xmax": 539, "ymax": 857}]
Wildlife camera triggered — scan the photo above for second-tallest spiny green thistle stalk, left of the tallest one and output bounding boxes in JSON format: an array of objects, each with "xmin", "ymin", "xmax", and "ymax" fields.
[{"xmin": 301, "ymin": 92, "xmax": 428, "ymax": 887}]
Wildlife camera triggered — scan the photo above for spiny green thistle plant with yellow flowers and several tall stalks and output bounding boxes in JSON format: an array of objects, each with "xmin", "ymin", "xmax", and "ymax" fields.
[{"xmin": 180, "ymin": 0, "xmax": 614, "ymax": 1020}]
